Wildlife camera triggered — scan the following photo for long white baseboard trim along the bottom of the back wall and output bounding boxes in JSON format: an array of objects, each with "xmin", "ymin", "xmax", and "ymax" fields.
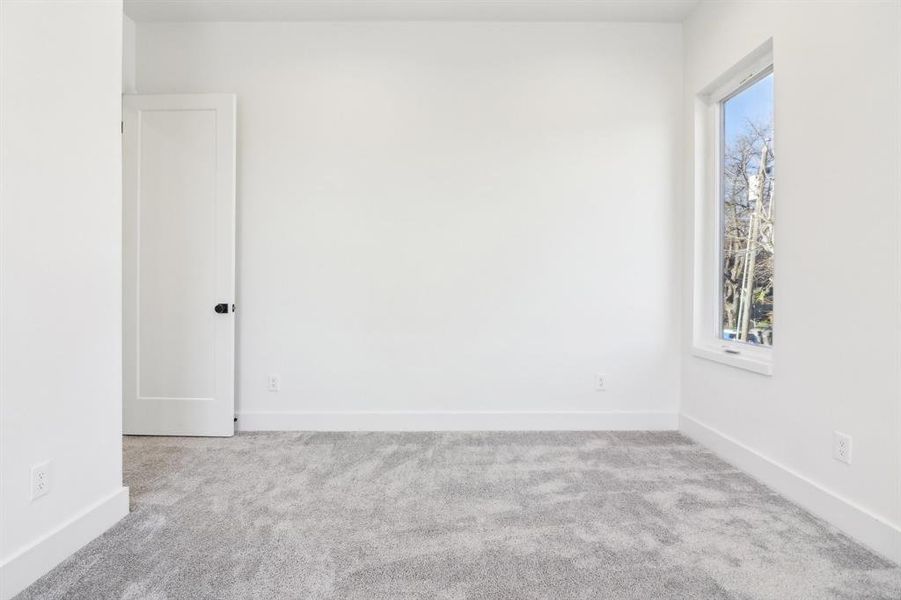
[{"xmin": 238, "ymin": 411, "xmax": 679, "ymax": 431}]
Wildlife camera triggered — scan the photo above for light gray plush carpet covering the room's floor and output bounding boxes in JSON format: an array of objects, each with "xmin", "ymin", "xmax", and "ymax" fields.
[{"xmin": 19, "ymin": 432, "xmax": 901, "ymax": 600}]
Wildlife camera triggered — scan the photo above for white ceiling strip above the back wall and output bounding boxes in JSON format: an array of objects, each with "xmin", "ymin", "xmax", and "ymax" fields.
[{"xmin": 125, "ymin": 0, "xmax": 699, "ymax": 22}]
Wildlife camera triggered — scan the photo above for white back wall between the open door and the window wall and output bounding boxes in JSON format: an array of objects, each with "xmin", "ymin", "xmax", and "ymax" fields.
[{"xmin": 137, "ymin": 23, "xmax": 682, "ymax": 428}]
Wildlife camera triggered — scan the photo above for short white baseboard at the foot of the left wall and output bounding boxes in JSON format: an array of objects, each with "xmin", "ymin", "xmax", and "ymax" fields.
[{"xmin": 0, "ymin": 487, "xmax": 128, "ymax": 600}]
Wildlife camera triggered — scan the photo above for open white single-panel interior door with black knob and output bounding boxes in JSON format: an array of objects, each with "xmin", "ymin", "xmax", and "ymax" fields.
[{"xmin": 123, "ymin": 94, "xmax": 235, "ymax": 436}]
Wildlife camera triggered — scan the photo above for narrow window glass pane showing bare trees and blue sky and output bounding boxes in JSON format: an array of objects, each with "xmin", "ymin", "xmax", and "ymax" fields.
[{"xmin": 717, "ymin": 68, "xmax": 776, "ymax": 346}]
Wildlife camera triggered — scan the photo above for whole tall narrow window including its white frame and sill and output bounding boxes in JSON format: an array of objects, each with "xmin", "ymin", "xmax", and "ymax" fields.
[{"xmin": 691, "ymin": 40, "xmax": 776, "ymax": 375}]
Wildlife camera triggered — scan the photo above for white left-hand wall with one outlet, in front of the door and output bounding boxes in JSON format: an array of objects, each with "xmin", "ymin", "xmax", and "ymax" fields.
[{"xmin": 0, "ymin": 0, "xmax": 128, "ymax": 598}]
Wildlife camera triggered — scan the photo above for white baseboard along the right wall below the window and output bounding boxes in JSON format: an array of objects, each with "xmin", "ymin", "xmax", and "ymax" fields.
[{"xmin": 679, "ymin": 415, "xmax": 901, "ymax": 564}]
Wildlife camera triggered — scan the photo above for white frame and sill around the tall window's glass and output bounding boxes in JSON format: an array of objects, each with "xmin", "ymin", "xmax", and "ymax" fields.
[{"xmin": 691, "ymin": 41, "xmax": 774, "ymax": 375}]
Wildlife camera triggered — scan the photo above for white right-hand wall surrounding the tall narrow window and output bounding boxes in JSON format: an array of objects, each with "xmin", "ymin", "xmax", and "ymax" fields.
[{"xmin": 682, "ymin": 2, "xmax": 901, "ymax": 560}]
